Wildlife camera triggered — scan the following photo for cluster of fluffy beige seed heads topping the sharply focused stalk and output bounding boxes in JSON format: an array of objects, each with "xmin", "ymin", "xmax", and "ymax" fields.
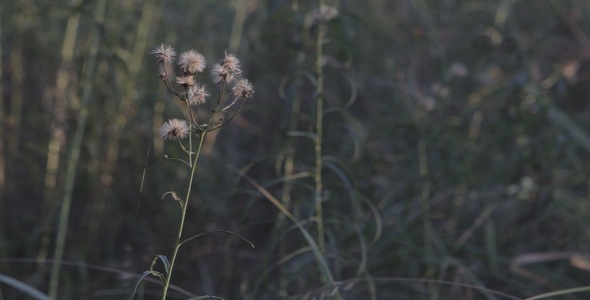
[{"xmin": 151, "ymin": 44, "xmax": 254, "ymax": 140}]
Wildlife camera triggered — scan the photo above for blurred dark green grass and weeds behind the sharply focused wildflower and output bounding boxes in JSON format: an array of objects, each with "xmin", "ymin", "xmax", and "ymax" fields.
[{"xmin": 0, "ymin": 0, "xmax": 590, "ymax": 299}]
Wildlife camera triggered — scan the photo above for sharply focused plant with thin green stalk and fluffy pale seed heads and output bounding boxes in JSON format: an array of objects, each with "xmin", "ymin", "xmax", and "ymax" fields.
[{"xmin": 146, "ymin": 44, "xmax": 254, "ymax": 300}]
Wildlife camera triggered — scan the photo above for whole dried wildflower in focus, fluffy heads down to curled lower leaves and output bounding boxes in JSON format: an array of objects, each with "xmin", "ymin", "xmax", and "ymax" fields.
[{"xmin": 131, "ymin": 44, "xmax": 254, "ymax": 299}]
